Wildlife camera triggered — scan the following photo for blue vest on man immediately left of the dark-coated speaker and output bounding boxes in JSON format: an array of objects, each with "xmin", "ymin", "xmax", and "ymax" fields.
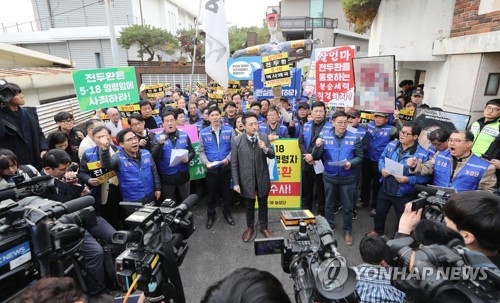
[{"xmin": 200, "ymin": 125, "xmax": 233, "ymax": 162}]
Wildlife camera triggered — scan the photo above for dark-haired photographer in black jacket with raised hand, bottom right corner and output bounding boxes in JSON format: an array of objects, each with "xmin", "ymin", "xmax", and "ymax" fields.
[{"xmin": 387, "ymin": 191, "xmax": 500, "ymax": 302}]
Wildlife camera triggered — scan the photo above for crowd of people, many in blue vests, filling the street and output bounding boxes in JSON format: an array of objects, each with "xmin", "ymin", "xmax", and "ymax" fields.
[{"xmin": 0, "ymin": 80, "xmax": 500, "ymax": 302}]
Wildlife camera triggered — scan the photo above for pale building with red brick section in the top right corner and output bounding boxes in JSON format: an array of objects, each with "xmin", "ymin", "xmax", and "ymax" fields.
[{"xmin": 368, "ymin": 0, "xmax": 500, "ymax": 121}]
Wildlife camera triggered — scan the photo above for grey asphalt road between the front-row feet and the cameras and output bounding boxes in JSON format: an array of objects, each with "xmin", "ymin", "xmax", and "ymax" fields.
[{"xmin": 180, "ymin": 199, "xmax": 395, "ymax": 303}]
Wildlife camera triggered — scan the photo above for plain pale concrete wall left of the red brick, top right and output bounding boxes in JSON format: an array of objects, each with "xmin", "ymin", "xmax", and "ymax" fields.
[{"xmin": 368, "ymin": 0, "xmax": 455, "ymax": 61}]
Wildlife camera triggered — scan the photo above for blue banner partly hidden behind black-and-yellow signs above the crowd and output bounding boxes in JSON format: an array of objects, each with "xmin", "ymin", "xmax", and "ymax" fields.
[{"xmin": 253, "ymin": 67, "xmax": 302, "ymax": 100}]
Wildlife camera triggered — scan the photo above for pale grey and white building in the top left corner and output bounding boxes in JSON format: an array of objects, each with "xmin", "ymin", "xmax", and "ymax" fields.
[{"xmin": 0, "ymin": 0, "xmax": 196, "ymax": 69}]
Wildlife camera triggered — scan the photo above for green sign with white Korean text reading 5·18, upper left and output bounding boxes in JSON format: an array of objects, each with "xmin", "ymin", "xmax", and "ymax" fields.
[{"xmin": 72, "ymin": 67, "xmax": 139, "ymax": 111}]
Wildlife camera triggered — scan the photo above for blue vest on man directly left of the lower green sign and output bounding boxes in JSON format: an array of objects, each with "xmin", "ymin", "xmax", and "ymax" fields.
[{"xmin": 156, "ymin": 130, "xmax": 189, "ymax": 175}]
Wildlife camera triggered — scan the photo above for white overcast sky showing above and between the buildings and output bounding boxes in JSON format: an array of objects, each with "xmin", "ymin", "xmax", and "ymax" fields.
[{"xmin": 0, "ymin": 0, "xmax": 279, "ymax": 32}]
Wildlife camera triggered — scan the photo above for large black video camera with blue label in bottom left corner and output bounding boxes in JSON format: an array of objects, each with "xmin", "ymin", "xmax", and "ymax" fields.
[{"xmin": 0, "ymin": 190, "xmax": 95, "ymax": 302}]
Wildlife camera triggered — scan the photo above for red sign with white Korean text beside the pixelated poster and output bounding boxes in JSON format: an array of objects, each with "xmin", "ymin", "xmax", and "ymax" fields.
[{"xmin": 316, "ymin": 46, "xmax": 355, "ymax": 107}]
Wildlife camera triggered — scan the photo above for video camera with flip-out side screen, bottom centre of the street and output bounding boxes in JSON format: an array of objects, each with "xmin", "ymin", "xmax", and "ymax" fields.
[{"xmin": 254, "ymin": 216, "xmax": 359, "ymax": 303}]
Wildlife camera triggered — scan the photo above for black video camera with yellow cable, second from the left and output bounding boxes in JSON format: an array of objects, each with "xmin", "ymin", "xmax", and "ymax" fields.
[{"xmin": 113, "ymin": 194, "xmax": 198, "ymax": 303}]
